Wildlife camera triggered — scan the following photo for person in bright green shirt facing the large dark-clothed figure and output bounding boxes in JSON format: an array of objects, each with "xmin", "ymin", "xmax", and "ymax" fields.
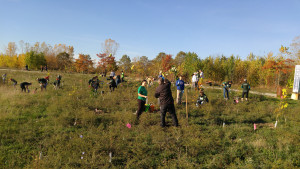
[{"xmin": 136, "ymin": 80, "xmax": 147, "ymax": 122}]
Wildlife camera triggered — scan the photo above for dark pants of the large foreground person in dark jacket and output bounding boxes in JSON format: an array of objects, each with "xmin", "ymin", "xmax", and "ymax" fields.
[{"xmin": 160, "ymin": 104, "xmax": 178, "ymax": 127}]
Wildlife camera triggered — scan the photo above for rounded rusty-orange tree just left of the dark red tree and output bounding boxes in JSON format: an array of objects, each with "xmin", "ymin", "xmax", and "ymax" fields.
[{"xmin": 74, "ymin": 54, "xmax": 93, "ymax": 73}]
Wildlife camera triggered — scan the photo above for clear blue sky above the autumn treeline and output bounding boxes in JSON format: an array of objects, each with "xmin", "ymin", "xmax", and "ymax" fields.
[{"xmin": 0, "ymin": 0, "xmax": 300, "ymax": 60}]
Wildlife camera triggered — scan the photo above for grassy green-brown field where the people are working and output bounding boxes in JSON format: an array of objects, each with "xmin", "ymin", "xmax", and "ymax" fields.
[{"xmin": 0, "ymin": 70, "xmax": 300, "ymax": 168}]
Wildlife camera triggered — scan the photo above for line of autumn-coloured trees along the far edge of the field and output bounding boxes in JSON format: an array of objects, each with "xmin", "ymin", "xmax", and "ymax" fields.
[{"xmin": 0, "ymin": 36, "xmax": 300, "ymax": 87}]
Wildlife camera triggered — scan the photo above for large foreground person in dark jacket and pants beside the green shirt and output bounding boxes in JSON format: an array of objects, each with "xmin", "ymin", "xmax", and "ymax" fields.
[{"xmin": 155, "ymin": 78, "xmax": 178, "ymax": 127}]
